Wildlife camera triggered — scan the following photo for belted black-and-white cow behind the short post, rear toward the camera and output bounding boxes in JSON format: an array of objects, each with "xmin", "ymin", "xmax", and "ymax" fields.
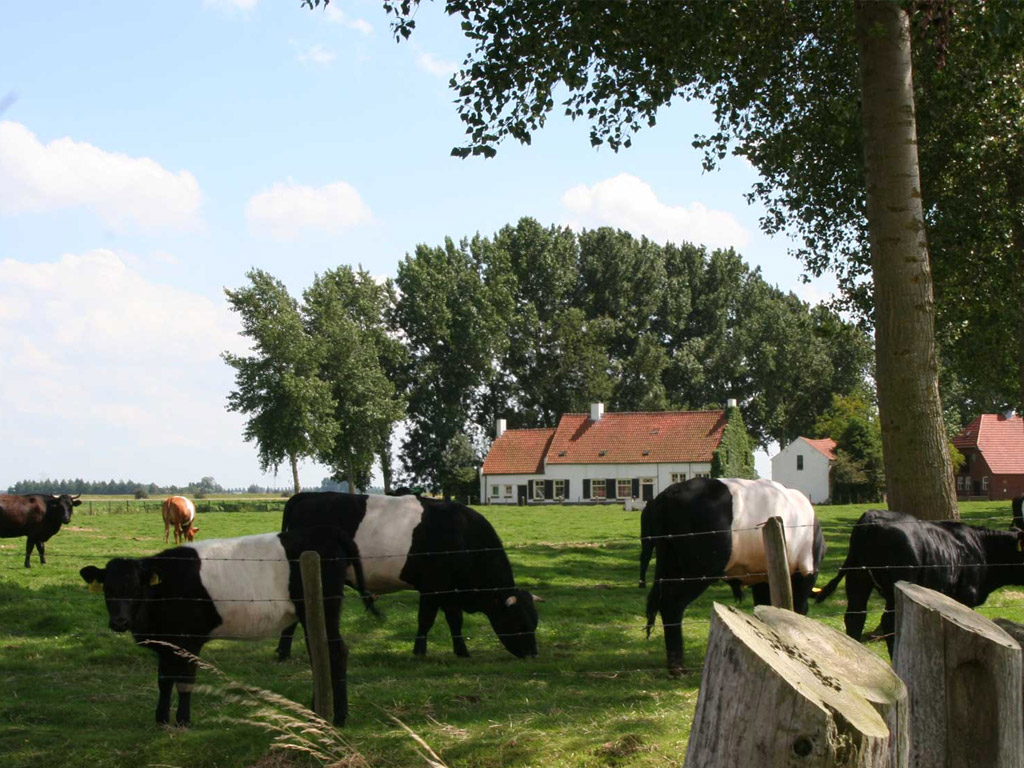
[{"xmin": 647, "ymin": 477, "xmax": 825, "ymax": 673}]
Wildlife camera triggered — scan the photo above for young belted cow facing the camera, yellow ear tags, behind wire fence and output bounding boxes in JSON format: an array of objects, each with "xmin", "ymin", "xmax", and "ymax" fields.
[{"xmin": 79, "ymin": 527, "xmax": 362, "ymax": 726}]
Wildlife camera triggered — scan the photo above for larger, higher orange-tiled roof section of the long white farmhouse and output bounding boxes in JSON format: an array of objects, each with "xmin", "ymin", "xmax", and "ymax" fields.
[{"xmin": 548, "ymin": 411, "xmax": 725, "ymax": 464}]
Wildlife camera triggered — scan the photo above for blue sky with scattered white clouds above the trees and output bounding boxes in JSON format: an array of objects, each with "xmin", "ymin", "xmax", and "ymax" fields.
[{"xmin": 0, "ymin": 0, "xmax": 834, "ymax": 489}]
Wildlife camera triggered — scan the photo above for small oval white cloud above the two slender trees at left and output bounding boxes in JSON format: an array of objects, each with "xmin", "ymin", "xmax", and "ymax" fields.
[{"xmin": 246, "ymin": 180, "xmax": 373, "ymax": 240}]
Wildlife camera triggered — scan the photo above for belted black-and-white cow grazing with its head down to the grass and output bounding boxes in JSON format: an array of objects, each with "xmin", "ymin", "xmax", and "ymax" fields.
[{"xmin": 278, "ymin": 493, "xmax": 538, "ymax": 659}]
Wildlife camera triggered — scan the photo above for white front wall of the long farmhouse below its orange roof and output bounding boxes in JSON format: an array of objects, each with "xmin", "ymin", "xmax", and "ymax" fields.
[{"xmin": 480, "ymin": 462, "xmax": 711, "ymax": 504}]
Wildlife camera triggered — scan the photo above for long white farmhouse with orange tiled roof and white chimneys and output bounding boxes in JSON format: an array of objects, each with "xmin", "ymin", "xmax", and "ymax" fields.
[{"xmin": 480, "ymin": 400, "xmax": 738, "ymax": 504}]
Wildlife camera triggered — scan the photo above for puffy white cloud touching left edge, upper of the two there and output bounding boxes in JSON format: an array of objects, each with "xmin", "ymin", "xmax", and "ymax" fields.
[{"xmin": 0, "ymin": 121, "xmax": 202, "ymax": 230}]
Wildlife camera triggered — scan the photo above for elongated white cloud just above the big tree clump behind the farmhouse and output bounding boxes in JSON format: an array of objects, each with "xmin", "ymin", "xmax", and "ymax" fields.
[{"xmin": 561, "ymin": 173, "xmax": 750, "ymax": 248}]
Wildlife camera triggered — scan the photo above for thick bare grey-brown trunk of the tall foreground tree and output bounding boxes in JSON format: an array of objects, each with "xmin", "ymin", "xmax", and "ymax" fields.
[{"xmin": 854, "ymin": 0, "xmax": 958, "ymax": 519}]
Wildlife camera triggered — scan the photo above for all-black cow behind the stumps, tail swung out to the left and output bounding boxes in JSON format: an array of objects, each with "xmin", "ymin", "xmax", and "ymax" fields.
[{"xmin": 815, "ymin": 509, "xmax": 1024, "ymax": 655}]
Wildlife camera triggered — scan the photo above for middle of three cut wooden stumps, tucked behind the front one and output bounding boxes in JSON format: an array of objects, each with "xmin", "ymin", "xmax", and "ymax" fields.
[{"xmin": 754, "ymin": 605, "xmax": 909, "ymax": 768}]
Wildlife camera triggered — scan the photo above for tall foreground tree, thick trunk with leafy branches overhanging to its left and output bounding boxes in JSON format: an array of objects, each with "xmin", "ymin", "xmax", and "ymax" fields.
[{"xmin": 307, "ymin": 0, "xmax": 956, "ymax": 517}]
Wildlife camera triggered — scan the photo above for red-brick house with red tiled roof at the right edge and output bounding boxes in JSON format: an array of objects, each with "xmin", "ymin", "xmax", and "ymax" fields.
[{"xmin": 953, "ymin": 413, "xmax": 1024, "ymax": 500}]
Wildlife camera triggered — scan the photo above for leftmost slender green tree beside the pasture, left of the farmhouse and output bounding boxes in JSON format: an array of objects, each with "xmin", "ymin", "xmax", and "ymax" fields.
[{"xmin": 221, "ymin": 269, "xmax": 337, "ymax": 493}]
